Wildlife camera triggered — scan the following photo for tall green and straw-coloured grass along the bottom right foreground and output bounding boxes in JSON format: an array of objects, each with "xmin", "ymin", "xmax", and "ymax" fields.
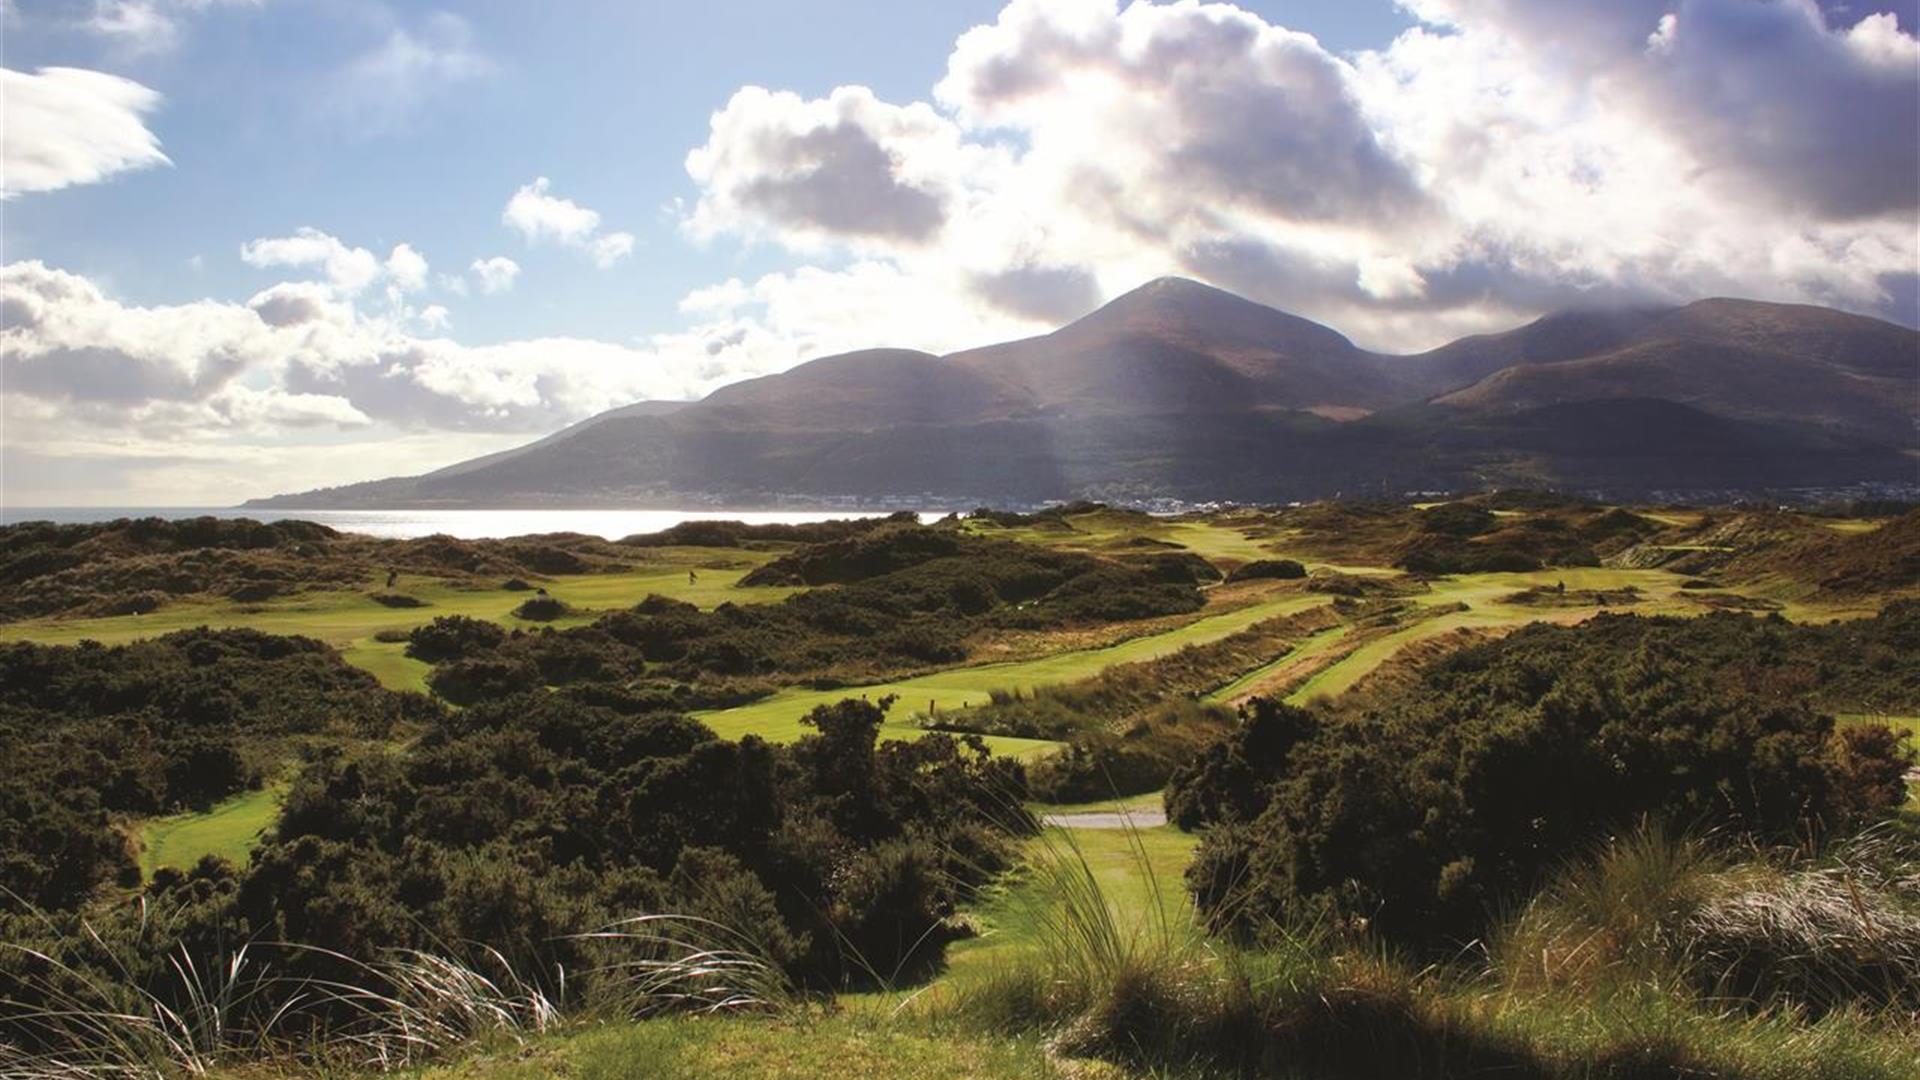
[{"xmin": 935, "ymin": 818, "xmax": 1920, "ymax": 1080}]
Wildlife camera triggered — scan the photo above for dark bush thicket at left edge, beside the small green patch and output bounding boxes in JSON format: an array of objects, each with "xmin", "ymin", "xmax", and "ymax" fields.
[{"xmin": 0, "ymin": 628, "xmax": 436, "ymax": 909}]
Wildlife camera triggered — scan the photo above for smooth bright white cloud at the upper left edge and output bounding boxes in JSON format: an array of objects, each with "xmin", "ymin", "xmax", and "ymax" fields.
[{"xmin": 0, "ymin": 67, "xmax": 171, "ymax": 198}]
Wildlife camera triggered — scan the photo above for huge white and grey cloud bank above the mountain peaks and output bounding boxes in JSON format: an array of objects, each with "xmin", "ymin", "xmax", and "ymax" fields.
[{"xmin": 685, "ymin": 0, "xmax": 1920, "ymax": 350}]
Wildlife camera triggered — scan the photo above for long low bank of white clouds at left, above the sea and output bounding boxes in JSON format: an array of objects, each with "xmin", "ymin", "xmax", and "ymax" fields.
[{"xmin": 0, "ymin": 259, "xmax": 791, "ymax": 455}]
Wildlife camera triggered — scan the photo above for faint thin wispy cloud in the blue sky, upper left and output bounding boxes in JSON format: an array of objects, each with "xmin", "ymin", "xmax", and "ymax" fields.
[{"xmin": 324, "ymin": 12, "xmax": 493, "ymax": 135}]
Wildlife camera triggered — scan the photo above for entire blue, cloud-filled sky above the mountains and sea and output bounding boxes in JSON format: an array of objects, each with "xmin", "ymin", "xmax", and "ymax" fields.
[{"xmin": 0, "ymin": 0, "xmax": 1920, "ymax": 505}]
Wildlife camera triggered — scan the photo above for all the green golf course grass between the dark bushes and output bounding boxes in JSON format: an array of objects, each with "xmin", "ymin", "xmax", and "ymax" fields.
[{"xmin": 0, "ymin": 509, "xmax": 1920, "ymax": 1080}]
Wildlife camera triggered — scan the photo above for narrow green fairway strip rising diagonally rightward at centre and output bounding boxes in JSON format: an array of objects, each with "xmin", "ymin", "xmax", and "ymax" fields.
[{"xmin": 695, "ymin": 594, "xmax": 1327, "ymax": 742}]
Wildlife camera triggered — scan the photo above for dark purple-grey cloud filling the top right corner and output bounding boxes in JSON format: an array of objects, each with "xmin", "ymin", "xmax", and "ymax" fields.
[{"xmin": 1415, "ymin": 0, "xmax": 1920, "ymax": 219}]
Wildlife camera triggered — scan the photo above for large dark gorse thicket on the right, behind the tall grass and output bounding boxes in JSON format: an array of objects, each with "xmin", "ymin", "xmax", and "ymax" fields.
[{"xmin": 1167, "ymin": 607, "xmax": 1920, "ymax": 942}]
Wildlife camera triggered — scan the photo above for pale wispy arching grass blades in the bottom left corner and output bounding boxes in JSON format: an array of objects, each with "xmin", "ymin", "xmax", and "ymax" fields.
[{"xmin": 0, "ymin": 903, "xmax": 797, "ymax": 1080}]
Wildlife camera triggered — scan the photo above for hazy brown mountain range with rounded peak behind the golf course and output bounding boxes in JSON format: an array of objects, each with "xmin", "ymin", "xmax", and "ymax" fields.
[{"xmin": 248, "ymin": 279, "xmax": 1920, "ymax": 509}]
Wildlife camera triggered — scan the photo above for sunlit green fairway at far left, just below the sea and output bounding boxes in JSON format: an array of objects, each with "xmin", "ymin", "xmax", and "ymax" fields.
[{"xmin": 0, "ymin": 548, "xmax": 799, "ymax": 690}]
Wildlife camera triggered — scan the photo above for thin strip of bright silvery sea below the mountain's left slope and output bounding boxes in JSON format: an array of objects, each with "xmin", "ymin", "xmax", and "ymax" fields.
[{"xmin": 0, "ymin": 505, "xmax": 943, "ymax": 540}]
